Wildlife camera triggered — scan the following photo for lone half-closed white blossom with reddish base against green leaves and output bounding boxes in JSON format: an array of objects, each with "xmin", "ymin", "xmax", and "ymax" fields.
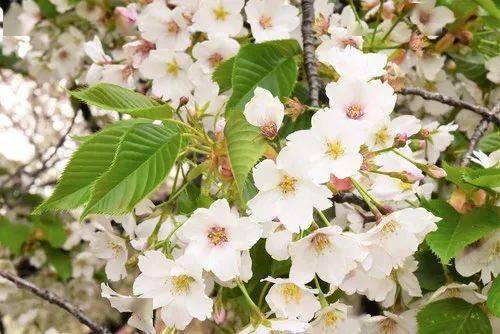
[{"xmin": 243, "ymin": 87, "xmax": 285, "ymax": 139}]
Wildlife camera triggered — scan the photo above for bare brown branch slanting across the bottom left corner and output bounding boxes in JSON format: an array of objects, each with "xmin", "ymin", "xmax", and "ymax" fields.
[{"xmin": 0, "ymin": 270, "xmax": 111, "ymax": 334}]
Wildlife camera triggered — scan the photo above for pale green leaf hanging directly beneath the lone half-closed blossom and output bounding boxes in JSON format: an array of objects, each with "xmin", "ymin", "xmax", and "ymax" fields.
[{"xmin": 224, "ymin": 113, "xmax": 266, "ymax": 203}]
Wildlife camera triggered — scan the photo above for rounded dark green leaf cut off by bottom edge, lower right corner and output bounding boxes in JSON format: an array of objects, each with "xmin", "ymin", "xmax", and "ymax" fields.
[{"xmin": 417, "ymin": 298, "xmax": 492, "ymax": 334}]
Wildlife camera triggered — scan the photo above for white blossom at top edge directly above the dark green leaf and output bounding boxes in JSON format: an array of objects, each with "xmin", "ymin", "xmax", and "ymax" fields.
[{"xmin": 245, "ymin": 0, "xmax": 300, "ymax": 43}]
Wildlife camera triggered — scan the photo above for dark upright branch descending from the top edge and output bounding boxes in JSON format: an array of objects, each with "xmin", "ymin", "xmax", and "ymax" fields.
[{"xmin": 301, "ymin": 0, "xmax": 322, "ymax": 107}]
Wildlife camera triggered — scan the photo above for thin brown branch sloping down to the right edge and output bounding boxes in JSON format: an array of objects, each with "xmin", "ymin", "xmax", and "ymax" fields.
[{"xmin": 398, "ymin": 87, "xmax": 500, "ymax": 125}]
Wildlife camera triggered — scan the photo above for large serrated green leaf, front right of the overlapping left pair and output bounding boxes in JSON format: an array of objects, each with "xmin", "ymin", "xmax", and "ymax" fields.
[{"xmin": 82, "ymin": 123, "xmax": 181, "ymax": 218}]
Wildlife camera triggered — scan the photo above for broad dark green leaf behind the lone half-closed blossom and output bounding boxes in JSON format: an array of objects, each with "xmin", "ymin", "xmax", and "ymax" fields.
[{"xmin": 227, "ymin": 40, "xmax": 302, "ymax": 112}]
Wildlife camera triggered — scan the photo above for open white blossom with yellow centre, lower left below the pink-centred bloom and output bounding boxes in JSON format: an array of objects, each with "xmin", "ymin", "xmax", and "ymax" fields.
[{"xmin": 133, "ymin": 251, "xmax": 213, "ymax": 329}]
